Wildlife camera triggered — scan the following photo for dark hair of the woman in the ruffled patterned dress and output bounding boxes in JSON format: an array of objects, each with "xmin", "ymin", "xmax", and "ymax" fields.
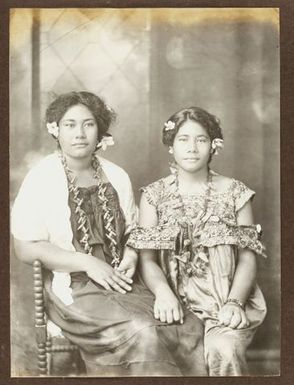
[{"xmin": 162, "ymin": 107, "xmax": 223, "ymax": 146}]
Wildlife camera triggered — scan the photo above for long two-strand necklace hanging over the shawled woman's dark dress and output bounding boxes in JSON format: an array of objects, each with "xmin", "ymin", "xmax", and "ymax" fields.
[{"xmin": 59, "ymin": 152, "xmax": 121, "ymax": 268}]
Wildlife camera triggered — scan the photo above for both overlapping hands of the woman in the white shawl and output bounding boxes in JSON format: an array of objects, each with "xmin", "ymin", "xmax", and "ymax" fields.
[{"xmin": 86, "ymin": 247, "xmax": 138, "ymax": 294}]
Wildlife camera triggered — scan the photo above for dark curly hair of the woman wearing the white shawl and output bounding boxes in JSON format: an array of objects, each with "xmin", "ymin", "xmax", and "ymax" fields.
[{"xmin": 45, "ymin": 91, "xmax": 116, "ymax": 140}]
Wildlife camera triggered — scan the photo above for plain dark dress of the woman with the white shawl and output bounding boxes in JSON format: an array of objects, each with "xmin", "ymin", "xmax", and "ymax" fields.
[{"xmin": 46, "ymin": 183, "xmax": 206, "ymax": 376}]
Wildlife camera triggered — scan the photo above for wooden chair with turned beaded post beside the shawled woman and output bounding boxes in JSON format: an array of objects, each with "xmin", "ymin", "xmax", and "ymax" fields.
[{"xmin": 33, "ymin": 260, "xmax": 85, "ymax": 376}]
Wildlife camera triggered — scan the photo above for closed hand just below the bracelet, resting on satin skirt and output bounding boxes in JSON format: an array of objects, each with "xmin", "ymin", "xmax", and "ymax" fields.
[{"xmin": 218, "ymin": 303, "xmax": 249, "ymax": 329}]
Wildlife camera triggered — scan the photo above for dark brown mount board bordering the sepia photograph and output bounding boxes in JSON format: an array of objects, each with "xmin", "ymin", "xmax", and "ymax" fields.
[{"xmin": 0, "ymin": 0, "xmax": 294, "ymax": 385}]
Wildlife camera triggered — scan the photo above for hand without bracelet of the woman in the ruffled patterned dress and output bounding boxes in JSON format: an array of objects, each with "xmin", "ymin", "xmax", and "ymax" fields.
[{"xmin": 154, "ymin": 287, "xmax": 184, "ymax": 324}]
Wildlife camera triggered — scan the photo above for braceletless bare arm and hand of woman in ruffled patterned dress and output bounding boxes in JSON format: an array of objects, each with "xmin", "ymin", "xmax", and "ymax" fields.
[{"xmin": 139, "ymin": 193, "xmax": 183, "ymax": 323}]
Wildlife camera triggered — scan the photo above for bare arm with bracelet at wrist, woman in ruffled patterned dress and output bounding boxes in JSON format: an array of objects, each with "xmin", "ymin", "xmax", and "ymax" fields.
[{"xmin": 219, "ymin": 201, "xmax": 257, "ymax": 329}]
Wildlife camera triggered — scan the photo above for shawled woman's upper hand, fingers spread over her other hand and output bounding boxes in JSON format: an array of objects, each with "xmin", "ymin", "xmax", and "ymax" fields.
[{"xmin": 86, "ymin": 257, "xmax": 133, "ymax": 294}]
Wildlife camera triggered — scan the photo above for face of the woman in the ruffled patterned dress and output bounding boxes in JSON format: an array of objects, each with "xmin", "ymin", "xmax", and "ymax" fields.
[{"xmin": 173, "ymin": 120, "xmax": 211, "ymax": 173}]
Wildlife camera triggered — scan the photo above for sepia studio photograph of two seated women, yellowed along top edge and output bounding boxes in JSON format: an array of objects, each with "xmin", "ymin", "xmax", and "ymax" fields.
[{"xmin": 9, "ymin": 7, "xmax": 281, "ymax": 381}]
